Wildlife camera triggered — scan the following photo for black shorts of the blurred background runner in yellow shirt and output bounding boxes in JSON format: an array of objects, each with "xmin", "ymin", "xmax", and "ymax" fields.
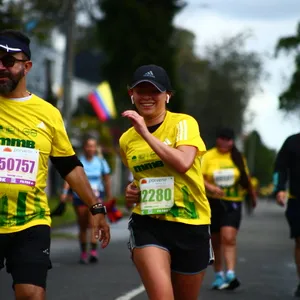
[{"xmin": 208, "ymin": 198, "xmax": 242, "ymax": 233}]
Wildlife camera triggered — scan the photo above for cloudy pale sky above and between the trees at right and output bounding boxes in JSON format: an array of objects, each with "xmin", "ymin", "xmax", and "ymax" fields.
[{"xmin": 175, "ymin": 0, "xmax": 300, "ymax": 149}]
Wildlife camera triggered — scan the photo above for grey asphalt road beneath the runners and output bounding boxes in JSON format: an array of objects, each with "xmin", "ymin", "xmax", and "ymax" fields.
[{"xmin": 0, "ymin": 201, "xmax": 297, "ymax": 300}]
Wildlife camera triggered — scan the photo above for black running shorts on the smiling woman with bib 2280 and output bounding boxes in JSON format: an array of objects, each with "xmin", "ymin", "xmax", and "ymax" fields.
[{"xmin": 128, "ymin": 214, "xmax": 213, "ymax": 274}]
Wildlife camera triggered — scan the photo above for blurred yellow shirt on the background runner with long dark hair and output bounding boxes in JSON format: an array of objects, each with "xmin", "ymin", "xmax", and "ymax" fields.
[{"xmin": 202, "ymin": 148, "xmax": 248, "ymax": 201}]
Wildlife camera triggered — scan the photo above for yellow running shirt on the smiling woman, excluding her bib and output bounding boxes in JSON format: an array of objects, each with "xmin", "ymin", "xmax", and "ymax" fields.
[{"xmin": 120, "ymin": 112, "xmax": 210, "ymax": 225}]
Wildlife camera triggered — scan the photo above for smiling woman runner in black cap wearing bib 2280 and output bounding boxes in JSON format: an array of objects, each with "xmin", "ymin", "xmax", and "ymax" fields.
[{"xmin": 120, "ymin": 65, "xmax": 213, "ymax": 300}]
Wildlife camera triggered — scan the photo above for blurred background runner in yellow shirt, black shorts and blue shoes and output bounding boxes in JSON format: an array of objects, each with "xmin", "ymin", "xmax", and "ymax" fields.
[{"xmin": 202, "ymin": 128, "xmax": 256, "ymax": 289}]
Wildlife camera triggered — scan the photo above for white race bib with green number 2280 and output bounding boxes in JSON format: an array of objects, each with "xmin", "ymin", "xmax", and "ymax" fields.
[{"xmin": 140, "ymin": 177, "xmax": 174, "ymax": 215}]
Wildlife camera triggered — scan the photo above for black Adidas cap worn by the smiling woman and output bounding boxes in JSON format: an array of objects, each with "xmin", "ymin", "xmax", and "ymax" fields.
[{"xmin": 129, "ymin": 65, "xmax": 173, "ymax": 92}]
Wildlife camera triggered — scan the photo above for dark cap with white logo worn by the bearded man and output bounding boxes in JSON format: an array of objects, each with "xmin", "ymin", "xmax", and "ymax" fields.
[{"xmin": 0, "ymin": 33, "xmax": 31, "ymax": 59}]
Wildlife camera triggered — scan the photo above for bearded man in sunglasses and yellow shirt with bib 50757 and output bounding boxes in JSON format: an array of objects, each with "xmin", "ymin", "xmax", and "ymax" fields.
[{"xmin": 0, "ymin": 30, "xmax": 110, "ymax": 300}]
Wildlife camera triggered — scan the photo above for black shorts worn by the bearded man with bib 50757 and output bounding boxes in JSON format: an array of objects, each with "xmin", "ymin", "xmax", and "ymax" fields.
[{"xmin": 0, "ymin": 225, "xmax": 51, "ymax": 288}]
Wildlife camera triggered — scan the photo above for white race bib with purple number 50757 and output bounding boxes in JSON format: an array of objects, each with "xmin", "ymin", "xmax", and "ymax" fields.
[{"xmin": 0, "ymin": 146, "xmax": 39, "ymax": 186}]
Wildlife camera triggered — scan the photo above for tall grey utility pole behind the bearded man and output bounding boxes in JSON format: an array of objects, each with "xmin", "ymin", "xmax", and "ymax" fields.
[{"xmin": 63, "ymin": 0, "xmax": 76, "ymax": 131}]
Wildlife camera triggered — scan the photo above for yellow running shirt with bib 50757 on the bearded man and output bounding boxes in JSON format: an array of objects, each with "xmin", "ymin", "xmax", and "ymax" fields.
[{"xmin": 0, "ymin": 95, "xmax": 75, "ymax": 234}]
